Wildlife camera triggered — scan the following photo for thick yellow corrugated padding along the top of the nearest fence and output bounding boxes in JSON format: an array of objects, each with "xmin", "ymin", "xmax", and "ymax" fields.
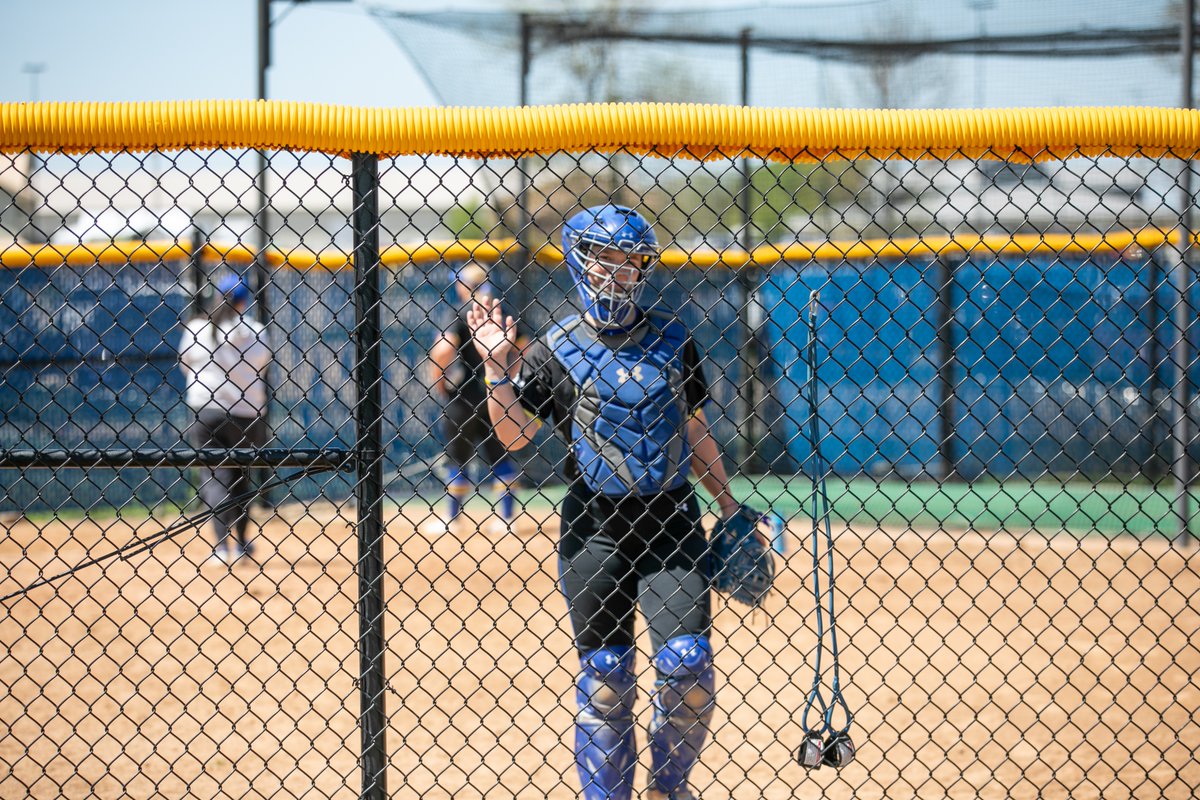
[{"xmin": 0, "ymin": 101, "xmax": 1200, "ymax": 161}]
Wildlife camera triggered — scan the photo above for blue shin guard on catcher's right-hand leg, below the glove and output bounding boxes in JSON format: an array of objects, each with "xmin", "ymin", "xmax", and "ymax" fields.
[{"xmin": 650, "ymin": 636, "xmax": 716, "ymax": 794}]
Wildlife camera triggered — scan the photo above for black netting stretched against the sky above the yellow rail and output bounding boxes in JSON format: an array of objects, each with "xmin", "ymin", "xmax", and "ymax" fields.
[{"xmin": 372, "ymin": 0, "xmax": 1183, "ymax": 108}]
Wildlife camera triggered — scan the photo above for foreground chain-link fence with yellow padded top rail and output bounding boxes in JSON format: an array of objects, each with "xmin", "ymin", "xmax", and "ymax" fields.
[{"xmin": 0, "ymin": 102, "xmax": 1200, "ymax": 800}]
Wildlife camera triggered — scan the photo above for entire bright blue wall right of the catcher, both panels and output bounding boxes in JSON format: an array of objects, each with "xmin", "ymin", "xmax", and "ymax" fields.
[{"xmin": 762, "ymin": 247, "xmax": 1180, "ymax": 480}]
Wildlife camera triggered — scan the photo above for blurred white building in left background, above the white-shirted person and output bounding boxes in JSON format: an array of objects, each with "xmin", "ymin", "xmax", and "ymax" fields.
[{"xmin": 14, "ymin": 151, "xmax": 496, "ymax": 251}]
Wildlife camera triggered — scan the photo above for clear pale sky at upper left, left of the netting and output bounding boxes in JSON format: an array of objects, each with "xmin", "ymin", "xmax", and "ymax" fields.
[{"xmin": 0, "ymin": 0, "xmax": 439, "ymax": 107}]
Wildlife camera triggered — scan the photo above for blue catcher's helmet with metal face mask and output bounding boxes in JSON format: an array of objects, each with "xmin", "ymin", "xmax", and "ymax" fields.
[{"xmin": 563, "ymin": 205, "xmax": 659, "ymax": 326}]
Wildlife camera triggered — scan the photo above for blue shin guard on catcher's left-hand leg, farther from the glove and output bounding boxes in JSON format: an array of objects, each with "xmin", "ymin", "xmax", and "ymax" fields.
[{"xmin": 575, "ymin": 646, "xmax": 637, "ymax": 800}]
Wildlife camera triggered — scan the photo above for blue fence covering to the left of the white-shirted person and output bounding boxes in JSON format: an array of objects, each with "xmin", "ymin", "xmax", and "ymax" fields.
[{"xmin": 0, "ymin": 261, "xmax": 191, "ymax": 510}]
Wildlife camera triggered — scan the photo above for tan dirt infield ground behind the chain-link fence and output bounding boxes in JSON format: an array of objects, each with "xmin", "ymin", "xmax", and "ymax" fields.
[{"xmin": 0, "ymin": 504, "xmax": 1200, "ymax": 800}]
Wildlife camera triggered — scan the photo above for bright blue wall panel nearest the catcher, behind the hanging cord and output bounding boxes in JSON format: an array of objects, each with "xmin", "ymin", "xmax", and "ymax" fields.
[{"xmin": 761, "ymin": 264, "xmax": 940, "ymax": 474}]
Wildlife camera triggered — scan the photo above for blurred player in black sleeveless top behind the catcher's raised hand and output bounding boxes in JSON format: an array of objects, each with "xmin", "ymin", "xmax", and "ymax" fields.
[{"xmin": 430, "ymin": 261, "xmax": 528, "ymax": 529}]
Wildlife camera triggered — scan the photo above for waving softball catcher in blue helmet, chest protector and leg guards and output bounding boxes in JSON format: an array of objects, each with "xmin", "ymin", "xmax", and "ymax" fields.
[{"xmin": 468, "ymin": 205, "xmax": 774, "ymax": 800}]
